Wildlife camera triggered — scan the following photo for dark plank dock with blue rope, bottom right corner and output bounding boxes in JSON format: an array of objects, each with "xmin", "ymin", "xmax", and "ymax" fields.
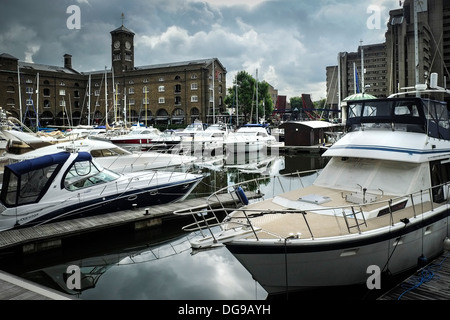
[{"xmin": 378, "ymin": 251, "xmax": 450, "ymax": 300}]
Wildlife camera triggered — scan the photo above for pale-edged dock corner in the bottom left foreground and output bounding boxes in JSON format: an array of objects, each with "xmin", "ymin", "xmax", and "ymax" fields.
[{"xmin": 0, "ymin": 271, "xmax": 74, "ymax": 300}]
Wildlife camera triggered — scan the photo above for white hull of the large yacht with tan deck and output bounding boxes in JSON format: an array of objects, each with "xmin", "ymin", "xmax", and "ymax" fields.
[{"xmin": 226, "ymin": 210, "xmax": 450, "ymax": 294}]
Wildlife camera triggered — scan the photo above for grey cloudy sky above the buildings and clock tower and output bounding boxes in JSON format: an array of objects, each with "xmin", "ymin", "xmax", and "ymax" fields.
[{"xmin": 0, "ymin": 0, "xmax": 400, "ymax": 100}]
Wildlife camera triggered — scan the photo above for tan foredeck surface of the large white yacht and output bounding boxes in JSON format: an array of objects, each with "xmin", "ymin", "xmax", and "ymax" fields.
[{"xmin": 227, "ymin": 186, "xmax": 439, "ymax": 239}]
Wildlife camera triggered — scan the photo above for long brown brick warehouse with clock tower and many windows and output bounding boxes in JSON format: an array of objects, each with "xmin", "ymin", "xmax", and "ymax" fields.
[{"xmin": 0, "ymin": 25, "xmax": 227, "ymax": 127}]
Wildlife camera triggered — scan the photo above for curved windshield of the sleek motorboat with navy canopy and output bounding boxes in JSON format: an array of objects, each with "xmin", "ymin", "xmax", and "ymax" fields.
[{"xmin": 64, "ymin": 161, "xmax": 120, "ymax": 191}]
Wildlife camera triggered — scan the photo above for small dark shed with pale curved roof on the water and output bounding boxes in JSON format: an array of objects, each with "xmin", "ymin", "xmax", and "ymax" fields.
[{"xmin": 280, "ymin": 120, "xmax": 342, "ymax": 146}]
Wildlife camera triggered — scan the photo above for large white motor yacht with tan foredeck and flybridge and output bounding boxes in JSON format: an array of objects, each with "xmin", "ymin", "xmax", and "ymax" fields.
[{"xmin": 177, "ymin": 82, "xmax": 450, "ymax": 293}]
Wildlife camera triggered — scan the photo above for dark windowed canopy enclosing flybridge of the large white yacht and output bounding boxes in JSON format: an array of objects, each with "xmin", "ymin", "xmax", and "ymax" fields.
[{"xmin": 347, "ymin": 98, "xmax": 450, "ymax": 140}]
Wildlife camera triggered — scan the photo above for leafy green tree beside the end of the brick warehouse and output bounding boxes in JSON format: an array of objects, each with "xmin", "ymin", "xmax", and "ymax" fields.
[{"xmin": 225, "ymin": 71, "xmax": 273, "ymax": 125}]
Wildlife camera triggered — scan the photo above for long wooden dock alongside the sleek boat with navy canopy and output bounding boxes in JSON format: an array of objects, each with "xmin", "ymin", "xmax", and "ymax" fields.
[{"xmin": 0, "ymin": 193, "xmax": 253, "ymax": 254}]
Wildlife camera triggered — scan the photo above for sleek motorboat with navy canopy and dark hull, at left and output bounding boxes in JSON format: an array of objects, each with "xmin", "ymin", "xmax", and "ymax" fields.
[{"xmin": 0, "ymin": 152, "xmax": 203, "ymax": 231}]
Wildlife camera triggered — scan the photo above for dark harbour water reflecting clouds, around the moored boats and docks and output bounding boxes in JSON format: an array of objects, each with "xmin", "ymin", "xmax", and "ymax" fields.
[{"xmin": 0, "ymin": 154, "xmax": 352, "ymax": 300}]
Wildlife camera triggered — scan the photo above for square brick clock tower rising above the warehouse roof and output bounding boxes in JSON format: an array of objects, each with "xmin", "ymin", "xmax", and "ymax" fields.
[{"xmin": 111, "ymin": 24, "xmax": 134, "ymax": 74}]
